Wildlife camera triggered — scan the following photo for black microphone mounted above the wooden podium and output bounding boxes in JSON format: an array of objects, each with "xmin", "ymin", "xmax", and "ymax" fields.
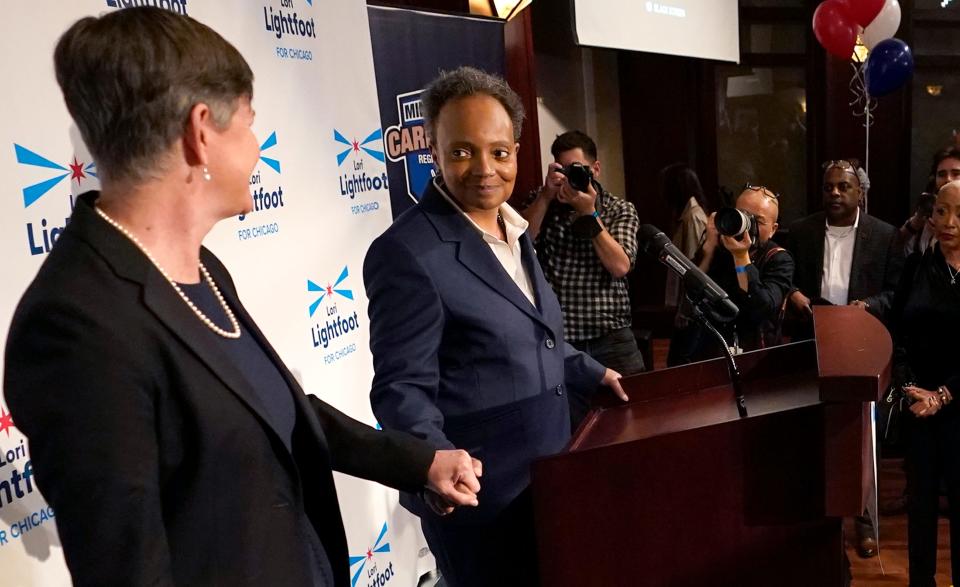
[{"xmin": 639, "ymin": 224, "xmax": 740, "ymax": 322}]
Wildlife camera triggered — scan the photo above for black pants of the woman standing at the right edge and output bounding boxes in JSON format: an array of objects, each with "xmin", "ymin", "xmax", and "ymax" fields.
[{"xmin": 904, "ymin": 404, "xmax": 960, "ymax": 587}]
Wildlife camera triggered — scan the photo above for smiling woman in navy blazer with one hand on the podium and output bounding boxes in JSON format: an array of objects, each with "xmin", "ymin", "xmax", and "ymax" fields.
[{"xmin": 363, "ymin": 67, "xmax": 626, "ymax": 587}]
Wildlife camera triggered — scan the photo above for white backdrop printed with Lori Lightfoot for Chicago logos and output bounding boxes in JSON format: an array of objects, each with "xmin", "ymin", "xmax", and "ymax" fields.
[{"xmin": 0, "ymin": 0, "xmax": 435, "ymax": 587}]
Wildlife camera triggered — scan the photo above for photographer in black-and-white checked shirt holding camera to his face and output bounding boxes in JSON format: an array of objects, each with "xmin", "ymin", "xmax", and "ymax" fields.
[{"xmin": 521, "ymin": 130, "xmax": 644, "ymax": 427}]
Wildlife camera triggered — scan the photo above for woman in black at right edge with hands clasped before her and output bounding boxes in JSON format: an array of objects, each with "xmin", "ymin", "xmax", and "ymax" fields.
[{"xmin": 893, "ymin": 181, "xmax": 960, "ymax": 587}]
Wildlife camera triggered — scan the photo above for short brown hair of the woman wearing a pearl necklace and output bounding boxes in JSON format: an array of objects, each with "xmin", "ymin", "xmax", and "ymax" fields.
[{"xmin": 53, "ymin": 6, "xmax": 253, "ymax": 180}]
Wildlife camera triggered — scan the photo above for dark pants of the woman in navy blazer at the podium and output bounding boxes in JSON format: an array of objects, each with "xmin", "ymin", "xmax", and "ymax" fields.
[{"xmin": 420, "ymin": 488, "xmax": 540, "ymax": 587}]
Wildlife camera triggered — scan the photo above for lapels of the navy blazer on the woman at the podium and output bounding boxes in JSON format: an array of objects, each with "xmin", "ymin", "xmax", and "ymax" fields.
[{"xmin": 419, "ymin": 182, "xmax": 553, "ymax": 331}]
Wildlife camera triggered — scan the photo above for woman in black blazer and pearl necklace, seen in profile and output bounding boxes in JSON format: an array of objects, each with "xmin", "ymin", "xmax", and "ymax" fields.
[{"xmin": 4, "ymin": 7, "xmax": 479, "ymax": 587}]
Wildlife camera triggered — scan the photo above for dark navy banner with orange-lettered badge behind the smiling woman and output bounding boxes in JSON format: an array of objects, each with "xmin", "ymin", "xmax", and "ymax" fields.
[{"xmin": 368, "ymin": 6, "xmax": 504, "ymax": 216}]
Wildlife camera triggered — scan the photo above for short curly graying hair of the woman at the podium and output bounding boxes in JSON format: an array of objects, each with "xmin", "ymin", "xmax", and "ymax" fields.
[{"xmin": 420, "ymin": 66, "xmax": 525, "ymax": 141}]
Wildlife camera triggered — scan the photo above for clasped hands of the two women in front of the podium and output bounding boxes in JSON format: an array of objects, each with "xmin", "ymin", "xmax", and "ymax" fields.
[{"xmin": 424, "ymin": 450, "xmax": 483, "ymax": 516}]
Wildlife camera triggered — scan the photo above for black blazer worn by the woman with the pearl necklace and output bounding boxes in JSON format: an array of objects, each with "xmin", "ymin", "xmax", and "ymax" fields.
[{"xmin": 4, "ymin": 192, "xmax": 434, "ymax": 587}]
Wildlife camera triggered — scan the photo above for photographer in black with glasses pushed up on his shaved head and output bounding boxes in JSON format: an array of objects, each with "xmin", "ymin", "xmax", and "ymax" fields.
[{"xmin": 670, "ymin": 184, "xmax": 793, "ymax": 364}]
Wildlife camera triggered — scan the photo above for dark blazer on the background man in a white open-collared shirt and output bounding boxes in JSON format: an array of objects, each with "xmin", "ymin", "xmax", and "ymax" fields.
[{"xmin": 786, "ymin": 212, "xmax": 903, "ymax": 317}]
